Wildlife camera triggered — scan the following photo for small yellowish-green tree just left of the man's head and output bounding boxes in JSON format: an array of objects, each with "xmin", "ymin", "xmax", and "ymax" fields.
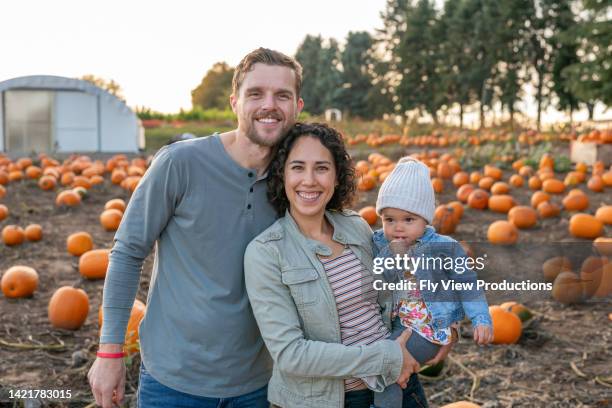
[{"xmin": 191, "ymin": 62, "xmax": 234, "ymax": 110}]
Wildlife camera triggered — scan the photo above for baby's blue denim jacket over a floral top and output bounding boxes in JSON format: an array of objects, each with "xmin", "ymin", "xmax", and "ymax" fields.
[{"xmin": 372, "ymin": 226, "xmax": 492, "ymax": 330}]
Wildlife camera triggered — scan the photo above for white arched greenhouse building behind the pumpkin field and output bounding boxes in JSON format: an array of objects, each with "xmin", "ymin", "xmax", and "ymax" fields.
[{"xmin": 0, "ymin": 75, "xmax": 144, "ymax": 154}]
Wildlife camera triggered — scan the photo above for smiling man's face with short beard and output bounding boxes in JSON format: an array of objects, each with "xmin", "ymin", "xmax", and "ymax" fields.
[{"xmin": 230, "ymin": 63, "xmax": 304, "ymax": 147}]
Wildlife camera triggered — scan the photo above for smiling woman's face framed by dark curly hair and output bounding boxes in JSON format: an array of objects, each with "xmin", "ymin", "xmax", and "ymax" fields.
[{"xmin": 284, "ymin": 135, "xmax": 336, "ymax": 217}]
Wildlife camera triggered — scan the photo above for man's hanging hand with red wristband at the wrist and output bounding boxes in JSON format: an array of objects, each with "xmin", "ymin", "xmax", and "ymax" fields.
[{"xmin": 87, "ymin": 344, "xmax": 125, "ymax": 408}]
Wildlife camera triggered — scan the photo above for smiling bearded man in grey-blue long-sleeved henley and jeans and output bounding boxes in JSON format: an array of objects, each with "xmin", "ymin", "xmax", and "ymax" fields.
[{"xmin": 88, "ymin": 48, "xmax": 303, "ymax": 408}]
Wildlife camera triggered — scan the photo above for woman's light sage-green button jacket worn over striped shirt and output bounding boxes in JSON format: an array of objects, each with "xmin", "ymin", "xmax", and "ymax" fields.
[{"xmin": 244, "ymin": 211, "xmax": 403, "ymax": 408}]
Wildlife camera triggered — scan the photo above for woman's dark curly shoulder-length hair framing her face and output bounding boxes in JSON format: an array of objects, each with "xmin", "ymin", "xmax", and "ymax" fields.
[{"xmin": 268, "ymin": 122, "xmax": 356, "ymax": 217}]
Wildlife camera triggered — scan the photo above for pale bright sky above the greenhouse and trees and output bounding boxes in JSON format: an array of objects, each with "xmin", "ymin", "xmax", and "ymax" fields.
[{"xmin": 0, "ymin": 0, "xmax": 612, "ymax": 123}]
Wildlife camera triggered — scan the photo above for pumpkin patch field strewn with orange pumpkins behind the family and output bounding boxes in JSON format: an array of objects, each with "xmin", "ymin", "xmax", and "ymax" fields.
[{"xmin": 0, "ymin": 133, "xmax": 612, "ymax": 408}]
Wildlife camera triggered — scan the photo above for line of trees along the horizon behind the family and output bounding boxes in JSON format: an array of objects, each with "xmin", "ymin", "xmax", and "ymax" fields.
[{"xmin": 192, "ymin": 0, "xmax": 612, "ymax": 126}]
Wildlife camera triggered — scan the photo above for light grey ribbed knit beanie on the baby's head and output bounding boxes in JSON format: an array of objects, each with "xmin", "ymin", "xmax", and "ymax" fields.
[{"xmin": 376, "ymin": 156, "xmax": 436, "ymax": 224}]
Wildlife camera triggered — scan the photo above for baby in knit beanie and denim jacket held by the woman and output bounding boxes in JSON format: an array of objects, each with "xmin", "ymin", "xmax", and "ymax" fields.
[{"xmin": 366, "ymin": 157, "xmax": 493, "ymax": 408}]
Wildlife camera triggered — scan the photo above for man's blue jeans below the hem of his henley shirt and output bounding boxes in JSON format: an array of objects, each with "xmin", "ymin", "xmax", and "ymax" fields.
[{"xmin": 138, "ymin": 364, "xmax": 270, "ymax": 408}]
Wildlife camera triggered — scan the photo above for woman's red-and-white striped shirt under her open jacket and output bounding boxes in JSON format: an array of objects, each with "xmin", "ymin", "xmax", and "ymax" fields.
[{"xmin": 321, "ymin": 248, "xmax": 389, "ymax": 392}]
